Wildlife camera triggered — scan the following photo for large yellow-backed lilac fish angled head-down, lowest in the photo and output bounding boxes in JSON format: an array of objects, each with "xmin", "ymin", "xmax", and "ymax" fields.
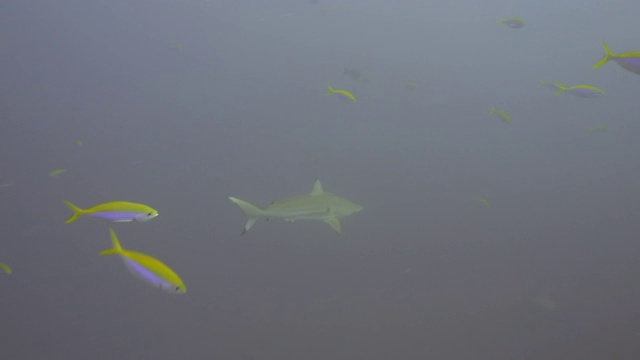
[{"xmin": 100, "ymin": 229, "xmax": 187, "ymax": 294}]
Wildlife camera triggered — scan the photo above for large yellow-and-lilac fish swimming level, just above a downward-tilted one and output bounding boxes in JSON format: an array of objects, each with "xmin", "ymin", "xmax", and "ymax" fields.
[{"xmin": 62, "ymin": 200, "xmax": 158, "ymax": 224}]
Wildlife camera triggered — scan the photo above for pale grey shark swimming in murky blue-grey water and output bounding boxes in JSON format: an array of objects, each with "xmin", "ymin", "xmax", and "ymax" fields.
[{"xmin": 229, "ymin": 179, "xmax": 362, "ymax": 235}]
